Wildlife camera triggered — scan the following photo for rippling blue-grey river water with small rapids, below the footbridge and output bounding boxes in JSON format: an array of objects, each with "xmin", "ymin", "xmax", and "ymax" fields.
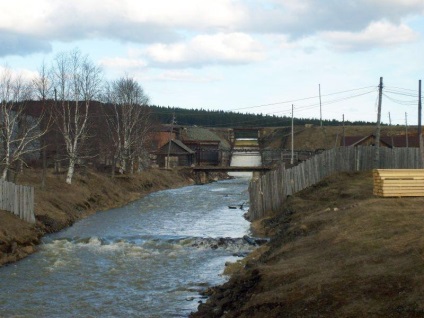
[{"xmin": 0, "ymin": 179, "xmax": 251, "ymax": 317}]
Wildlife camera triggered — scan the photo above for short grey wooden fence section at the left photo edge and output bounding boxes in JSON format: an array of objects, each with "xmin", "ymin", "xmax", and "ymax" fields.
[{"xmin": 0, "ymin": 180, "xmax": 35, "ymax": 223}]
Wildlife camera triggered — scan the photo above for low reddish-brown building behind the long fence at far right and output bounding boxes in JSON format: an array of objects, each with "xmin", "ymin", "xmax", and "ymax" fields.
[{"xmin": 340, "ymin": 134, "xmax": 420, "ymax": 148}]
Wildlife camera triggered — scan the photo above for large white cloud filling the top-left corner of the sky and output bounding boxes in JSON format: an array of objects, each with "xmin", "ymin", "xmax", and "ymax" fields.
[{"xmin": 0, "ymin": 0, "xmax": 246, "ymax": 38}]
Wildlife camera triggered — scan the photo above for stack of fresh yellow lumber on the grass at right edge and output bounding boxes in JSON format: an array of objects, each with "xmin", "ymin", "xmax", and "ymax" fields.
[{"xmin": 373, "ymin": 169, "xmax": 424, "ymax": 197}]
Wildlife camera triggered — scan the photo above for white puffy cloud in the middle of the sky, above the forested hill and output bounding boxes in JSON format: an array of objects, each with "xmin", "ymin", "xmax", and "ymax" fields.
[{"xmin": 146, "ymin": 33, "xmax": 265, "ymax": 66}]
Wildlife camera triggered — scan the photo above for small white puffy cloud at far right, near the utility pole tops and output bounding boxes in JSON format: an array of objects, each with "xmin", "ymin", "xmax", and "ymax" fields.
[{"xmin": 321, "ymin": 21, "xmax": 418, "ymax": 51}]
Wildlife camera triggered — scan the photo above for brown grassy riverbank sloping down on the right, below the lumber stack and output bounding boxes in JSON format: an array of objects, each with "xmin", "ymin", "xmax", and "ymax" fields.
[{"xmin": 191, "ymin": 173, "xmax": 424, "ymax": 318}]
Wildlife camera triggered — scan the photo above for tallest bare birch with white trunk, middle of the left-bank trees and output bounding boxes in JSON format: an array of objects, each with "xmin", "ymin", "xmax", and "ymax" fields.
[{"xmin": 53, "ymin": 50, "xmax": 101, "ymax": 184}]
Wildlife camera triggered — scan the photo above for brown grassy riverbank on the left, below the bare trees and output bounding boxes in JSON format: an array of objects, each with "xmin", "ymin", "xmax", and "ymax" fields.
[{"xmin": 0, "ymin": 169, "xmax": 194, "ymax": 266}]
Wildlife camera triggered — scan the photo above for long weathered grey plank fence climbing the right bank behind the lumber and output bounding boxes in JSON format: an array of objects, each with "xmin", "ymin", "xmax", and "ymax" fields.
[{"xmin": 249, "ymin": 147, "xmax": 422, "ymax": 220}]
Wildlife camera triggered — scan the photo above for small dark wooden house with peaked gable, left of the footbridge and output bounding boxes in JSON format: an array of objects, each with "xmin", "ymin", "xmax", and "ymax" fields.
[{"xmin": 155, "ymin": 140, "xmax": 195, "ymax": 168}]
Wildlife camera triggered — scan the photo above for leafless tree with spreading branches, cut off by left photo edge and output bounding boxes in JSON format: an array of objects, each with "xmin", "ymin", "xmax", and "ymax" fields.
[{"xmin": 0, "ymin": 68, "xmax": 45, "ymax": 180}]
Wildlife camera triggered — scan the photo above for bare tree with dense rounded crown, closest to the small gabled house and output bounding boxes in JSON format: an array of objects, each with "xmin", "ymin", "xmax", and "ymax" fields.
[{"xmin": 105, "ymin": 76, "xmax": 151, "ymax": 173}]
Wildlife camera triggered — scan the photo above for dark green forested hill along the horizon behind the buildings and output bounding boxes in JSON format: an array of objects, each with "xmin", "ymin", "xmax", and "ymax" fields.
[{"xmin": 150, "ymin": 106, "xmax": 372, "ymax": 127}]
